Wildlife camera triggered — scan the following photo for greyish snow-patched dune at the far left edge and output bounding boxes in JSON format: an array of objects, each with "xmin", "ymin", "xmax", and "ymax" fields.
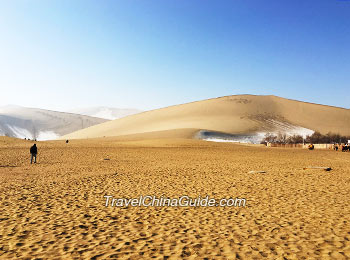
[{"xmin": 0, "ymin": 105, "xmax": 108, "ymax": 140}]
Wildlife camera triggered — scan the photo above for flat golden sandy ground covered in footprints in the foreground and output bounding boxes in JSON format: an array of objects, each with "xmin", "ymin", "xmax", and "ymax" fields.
[{"xmin": 0, "ymin": 138, "xmax": 350, "ymax": 259}]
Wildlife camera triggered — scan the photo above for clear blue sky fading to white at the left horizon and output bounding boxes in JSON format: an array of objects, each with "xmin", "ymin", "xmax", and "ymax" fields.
[{"xmin": 0, "ymin": 0, "xmax": 350, "ymax": 110}]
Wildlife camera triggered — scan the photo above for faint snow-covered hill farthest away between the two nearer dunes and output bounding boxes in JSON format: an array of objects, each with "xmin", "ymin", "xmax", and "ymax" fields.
[{"xmin": 68, "ymin": 107, "xmax": 142, "ymax": 120}]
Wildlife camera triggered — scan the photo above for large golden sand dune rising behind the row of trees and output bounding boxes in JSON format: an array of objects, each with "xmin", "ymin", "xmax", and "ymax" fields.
[{"xmin": 64, "ymin": 95, "xmax": 350, "ymax": 139}]
